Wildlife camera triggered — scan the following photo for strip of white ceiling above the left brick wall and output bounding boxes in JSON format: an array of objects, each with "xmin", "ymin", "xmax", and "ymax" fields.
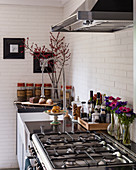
[{"xmin": 0, "ymin": 0, "xmax": 68, "ymax": 7}]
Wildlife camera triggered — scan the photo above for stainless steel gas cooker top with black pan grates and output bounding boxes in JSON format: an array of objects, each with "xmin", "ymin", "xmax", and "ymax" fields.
[{"xmin": 32, "ymin": 131, "xmax": 136, "ymax": 170}]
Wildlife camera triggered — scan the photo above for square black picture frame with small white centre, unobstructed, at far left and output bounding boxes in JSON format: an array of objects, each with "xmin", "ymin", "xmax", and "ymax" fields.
[{"xmin": 3, "ymin": 38, "xmax": 25, "ymax": 59}]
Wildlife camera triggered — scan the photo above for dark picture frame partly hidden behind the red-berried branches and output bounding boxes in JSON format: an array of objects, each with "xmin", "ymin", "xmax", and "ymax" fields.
[{"xmin": 33, "ymin": 52, "xmax": 54, "ymax": 73}]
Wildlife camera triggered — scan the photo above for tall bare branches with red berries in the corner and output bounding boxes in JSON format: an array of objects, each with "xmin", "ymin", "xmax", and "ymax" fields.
[{"xmin": 24, "ymin": 32, "xmax": 71, "ymax": 98}]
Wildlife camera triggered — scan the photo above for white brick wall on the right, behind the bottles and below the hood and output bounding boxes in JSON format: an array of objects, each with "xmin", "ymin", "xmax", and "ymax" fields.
[{"xmin": 64, "ymin": 0, "xmax": 136, "ymax": 142}]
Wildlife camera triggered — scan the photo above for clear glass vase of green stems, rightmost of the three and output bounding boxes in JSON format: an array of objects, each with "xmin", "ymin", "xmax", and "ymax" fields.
[{"xmin": 123, "ymin": 123, "xmax": 131, "ymax": 145}]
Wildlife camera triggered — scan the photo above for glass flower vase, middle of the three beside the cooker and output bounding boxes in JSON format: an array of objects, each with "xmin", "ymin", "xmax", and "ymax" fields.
[{"xmin": 114, "ymin": 117, "xmax": 122, "ymax": 140}]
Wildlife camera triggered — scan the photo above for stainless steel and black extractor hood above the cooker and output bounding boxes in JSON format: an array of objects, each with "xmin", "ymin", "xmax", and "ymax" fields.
[{"xmin": 52, "ymin": 0, "xmax": 133, "ymax": 32}]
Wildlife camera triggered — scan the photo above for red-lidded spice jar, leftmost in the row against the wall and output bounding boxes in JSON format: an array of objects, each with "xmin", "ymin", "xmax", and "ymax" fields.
[{"xmin": 17, "ymin": 83, "xmax": 26, "ymax": 102}]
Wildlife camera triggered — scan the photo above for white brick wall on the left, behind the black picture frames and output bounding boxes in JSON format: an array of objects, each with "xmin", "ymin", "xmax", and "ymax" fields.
[{"xmin": 0, "ymin": 5, "xmax": 62, "ymax": 169}]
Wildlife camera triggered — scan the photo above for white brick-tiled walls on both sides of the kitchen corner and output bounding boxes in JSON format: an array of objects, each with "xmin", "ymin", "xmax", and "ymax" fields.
[{"xmin": 0, "ymin": 0, "xmax": 136, "ymax": 168}]
